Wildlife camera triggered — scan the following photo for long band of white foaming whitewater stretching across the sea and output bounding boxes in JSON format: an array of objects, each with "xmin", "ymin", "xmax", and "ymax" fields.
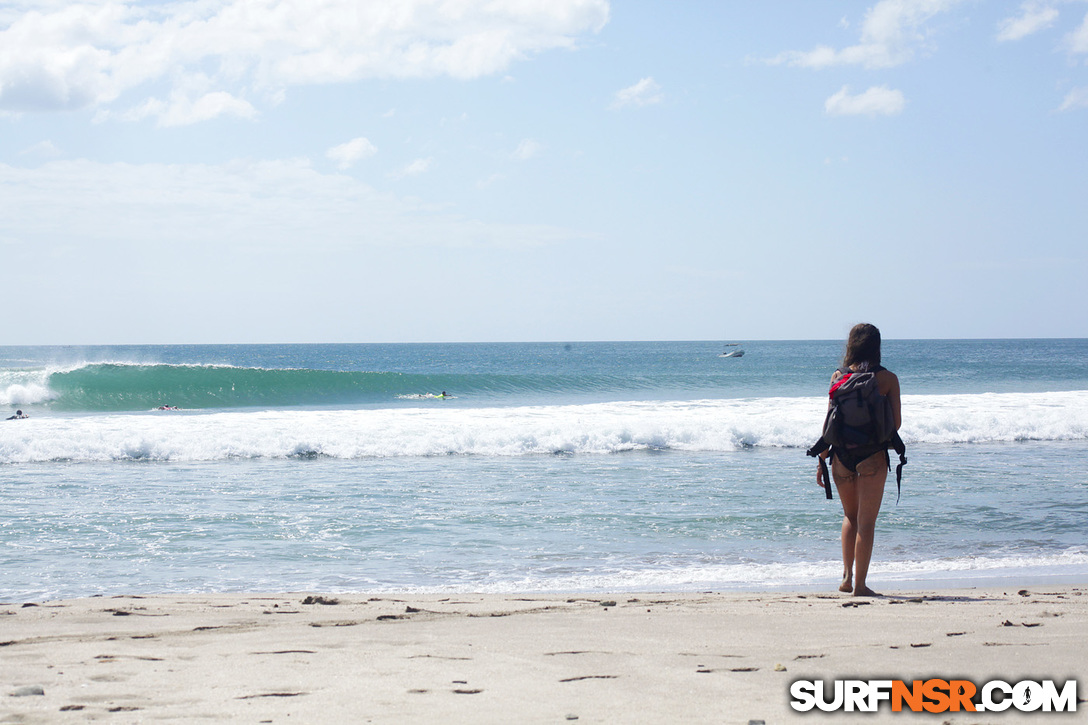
[{"xmin": 0, "ymin": 391, "xmax": 1088, "ymax": 464}]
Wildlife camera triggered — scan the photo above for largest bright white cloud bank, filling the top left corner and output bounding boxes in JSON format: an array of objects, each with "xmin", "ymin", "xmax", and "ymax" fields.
[{"xmin": 0, "ymin": 0, "xmax": 609, "ymax": 118}]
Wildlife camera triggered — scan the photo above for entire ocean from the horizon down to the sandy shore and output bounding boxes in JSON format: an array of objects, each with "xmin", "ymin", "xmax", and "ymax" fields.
[{"xmin": 0, "ymin": 340, "xmax": 1088, "ymax": 602}]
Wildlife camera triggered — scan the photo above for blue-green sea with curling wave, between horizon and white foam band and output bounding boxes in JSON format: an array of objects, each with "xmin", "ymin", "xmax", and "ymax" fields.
[{"xmin": 6, "ymin": 340, "xmax": 1088, "ymax": 415}]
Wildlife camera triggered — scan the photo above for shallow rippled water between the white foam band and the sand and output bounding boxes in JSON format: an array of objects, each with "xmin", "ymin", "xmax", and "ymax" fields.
[{"xmin": 0, "ymin": 442, "xmax": 1088, "ymax": 600}]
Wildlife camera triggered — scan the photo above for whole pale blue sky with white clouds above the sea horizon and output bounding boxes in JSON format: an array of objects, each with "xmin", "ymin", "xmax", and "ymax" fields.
[{"xmin": 0, "ymin": 0, "xmax": 1088, "ymax": 345}]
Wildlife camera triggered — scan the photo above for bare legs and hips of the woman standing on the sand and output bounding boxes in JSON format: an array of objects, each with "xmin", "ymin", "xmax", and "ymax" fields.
[{"xmin": 831, "ymin": 452, "xmax": 888, "ymax": 597}]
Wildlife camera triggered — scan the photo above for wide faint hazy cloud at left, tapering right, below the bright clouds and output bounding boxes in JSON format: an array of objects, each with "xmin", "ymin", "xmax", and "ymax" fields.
[{"xmin": 0, "ymin": 160, "xmax": 582, "ymax": 250}]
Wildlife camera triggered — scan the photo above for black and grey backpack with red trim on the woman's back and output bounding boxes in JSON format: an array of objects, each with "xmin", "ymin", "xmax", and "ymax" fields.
[{"xmin": 807, "ymin": 368, "xmax": 906, "ymax": 496}]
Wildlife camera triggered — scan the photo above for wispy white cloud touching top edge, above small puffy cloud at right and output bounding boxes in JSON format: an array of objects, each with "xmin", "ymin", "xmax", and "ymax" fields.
[{"xmin": 769, "ymin": 0, "xmax": 963, "ymax": 69}]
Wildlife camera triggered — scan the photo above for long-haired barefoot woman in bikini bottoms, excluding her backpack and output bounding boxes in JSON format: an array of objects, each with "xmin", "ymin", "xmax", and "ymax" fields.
[{"xmin": 816, "ymin": 322, "xmax": 903, "ymax": 597}]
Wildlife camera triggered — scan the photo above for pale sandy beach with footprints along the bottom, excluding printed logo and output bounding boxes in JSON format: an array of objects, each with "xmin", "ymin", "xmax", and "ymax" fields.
[{"xmin": 0, "ymin": 587, "xmax": 1088, "ymax": 724}]
